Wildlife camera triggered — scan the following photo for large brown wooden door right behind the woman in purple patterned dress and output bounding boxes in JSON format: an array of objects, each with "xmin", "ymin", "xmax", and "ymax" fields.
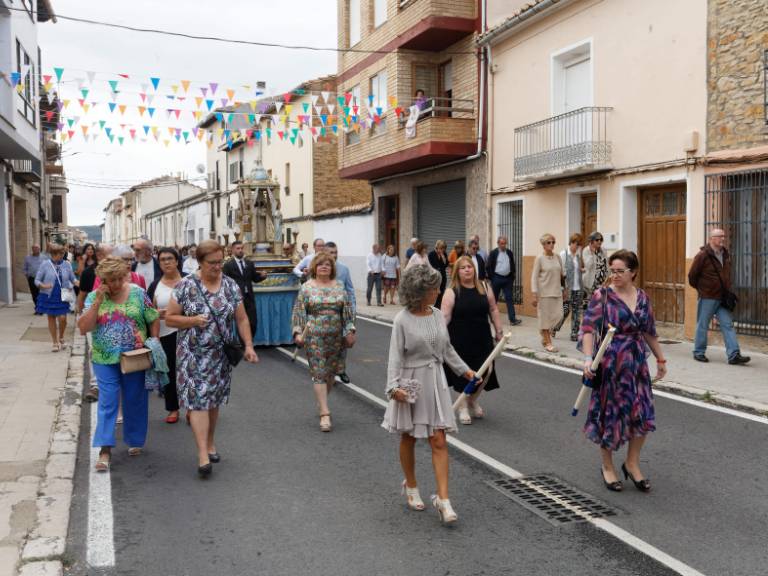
[{"xmin": 638, "ymin": 184, "xmax": 686, "ymax": 324}]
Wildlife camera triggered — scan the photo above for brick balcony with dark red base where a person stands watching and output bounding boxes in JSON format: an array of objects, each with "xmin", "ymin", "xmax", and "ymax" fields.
[{"xmin": 339, "ymin": 98, "xmax": 477, "ymax": 180}]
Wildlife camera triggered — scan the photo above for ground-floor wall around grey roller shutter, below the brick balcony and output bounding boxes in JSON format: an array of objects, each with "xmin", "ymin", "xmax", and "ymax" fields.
[{"xmin": 373, "ymin": 157, "xmax": 492, "ymax": 261}]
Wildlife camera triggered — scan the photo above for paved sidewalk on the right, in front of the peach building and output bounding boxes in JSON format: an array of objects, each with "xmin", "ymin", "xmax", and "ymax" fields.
[{"xmin": 356, "ymin": 290, "xmax": 768, "ymax": 416}]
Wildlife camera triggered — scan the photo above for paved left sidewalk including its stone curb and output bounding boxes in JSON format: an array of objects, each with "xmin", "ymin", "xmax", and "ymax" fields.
[{"xmin": 0, "ymin": 302, "xmax": 84, "ymax": 576}]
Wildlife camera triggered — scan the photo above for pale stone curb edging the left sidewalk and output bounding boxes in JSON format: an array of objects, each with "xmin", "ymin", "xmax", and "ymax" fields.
[{"xmin": 18, "ymin": 330, "xmax": 86, "ymax": 576}]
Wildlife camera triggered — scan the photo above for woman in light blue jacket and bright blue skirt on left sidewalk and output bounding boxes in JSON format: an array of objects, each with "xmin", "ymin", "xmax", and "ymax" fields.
[{"xmin": 35, "ymin": 244, "xmax": 77, "ymax": 352}]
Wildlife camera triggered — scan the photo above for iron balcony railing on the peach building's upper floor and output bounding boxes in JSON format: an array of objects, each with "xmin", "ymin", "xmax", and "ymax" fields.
[{"xmin": 515, "ymin": 106, "xmax": 613, "ymax": 180}]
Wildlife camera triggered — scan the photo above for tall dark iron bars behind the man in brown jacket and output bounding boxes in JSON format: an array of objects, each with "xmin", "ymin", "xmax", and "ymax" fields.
[{"xmin": 704, "ymin": 169, "xmax": 768, "ymax": 337}]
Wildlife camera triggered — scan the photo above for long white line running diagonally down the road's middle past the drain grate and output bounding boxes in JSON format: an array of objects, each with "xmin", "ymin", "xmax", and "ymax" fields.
[{"xmin": 277, "ymin": 346, "xmax": 704, "ymax": 576}]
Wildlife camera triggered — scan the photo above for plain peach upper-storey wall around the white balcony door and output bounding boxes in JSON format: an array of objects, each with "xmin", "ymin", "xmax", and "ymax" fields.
[{"xmin": 489, "ymin": 0, "xmax": 707, "ymax": 190}]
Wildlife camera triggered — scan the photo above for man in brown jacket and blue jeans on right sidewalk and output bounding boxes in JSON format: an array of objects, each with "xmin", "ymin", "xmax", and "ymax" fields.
[{"xmin": 688, "ymin": 229, "xmax": 750, "ymax": 365}]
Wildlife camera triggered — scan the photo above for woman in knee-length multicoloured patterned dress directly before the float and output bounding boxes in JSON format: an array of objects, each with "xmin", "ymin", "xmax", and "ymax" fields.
[{"xmin": 292, "ymin": 252, "xmax": 355, "ymax": 432}]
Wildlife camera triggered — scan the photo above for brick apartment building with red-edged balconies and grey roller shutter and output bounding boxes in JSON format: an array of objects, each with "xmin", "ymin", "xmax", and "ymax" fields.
[{"xmin": 338, "ymin": 0, "xmax": 489, "ymax": 257}]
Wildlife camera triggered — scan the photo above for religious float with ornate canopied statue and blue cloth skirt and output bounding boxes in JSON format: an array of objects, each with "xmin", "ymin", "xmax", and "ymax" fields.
[{"xmin": 235, "ymin": 162, "xmax": 299, "ymax": 346}]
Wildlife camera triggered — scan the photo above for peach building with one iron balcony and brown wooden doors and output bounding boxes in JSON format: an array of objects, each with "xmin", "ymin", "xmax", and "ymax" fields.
[{"xmin": 479, "ymin": 0, "xmax": 708, "ymax": 336}]
